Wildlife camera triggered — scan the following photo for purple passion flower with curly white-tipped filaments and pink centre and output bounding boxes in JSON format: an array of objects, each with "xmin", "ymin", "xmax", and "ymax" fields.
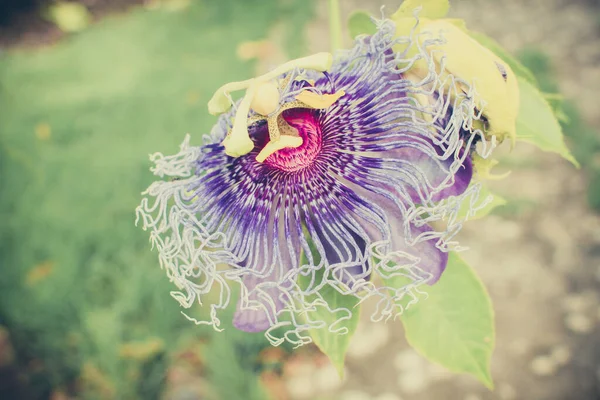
[{"xmin": 137, "ymin": 21, "xmax": 488, "ymax": 343}]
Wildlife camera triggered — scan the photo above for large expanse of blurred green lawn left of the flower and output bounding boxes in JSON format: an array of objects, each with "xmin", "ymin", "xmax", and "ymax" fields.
[{"xmin": 0, "ymin": 0, "xmax": 312, "ymax": 399}]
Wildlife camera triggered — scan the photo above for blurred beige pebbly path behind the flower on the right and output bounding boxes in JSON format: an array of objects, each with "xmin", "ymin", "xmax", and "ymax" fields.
[{"xmin": 288, "ymin": 0, "xmax": 600, "ymax": 400}]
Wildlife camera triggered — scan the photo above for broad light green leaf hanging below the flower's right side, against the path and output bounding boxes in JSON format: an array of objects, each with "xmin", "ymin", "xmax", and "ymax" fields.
[{"xmin": 401, "ymin": 253, "xmax": 495, "ymax": 389}]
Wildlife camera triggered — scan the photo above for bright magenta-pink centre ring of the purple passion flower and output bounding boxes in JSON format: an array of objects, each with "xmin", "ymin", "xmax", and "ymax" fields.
[{"xmin": 264, "ymin": 108, "xmax": 322, "ymax": 172}]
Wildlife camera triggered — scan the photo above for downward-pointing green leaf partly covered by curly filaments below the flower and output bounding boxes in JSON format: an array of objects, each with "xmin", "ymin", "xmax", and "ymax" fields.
[{"xmin": 298, "ymin": 254, "xmax": 360, "ymax": 377}]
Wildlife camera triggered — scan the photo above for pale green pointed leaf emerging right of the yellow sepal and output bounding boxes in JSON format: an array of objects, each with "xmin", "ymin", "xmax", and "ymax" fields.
[{"xmin": 517, "ymin": 78, "xmax": 579, "ymax": 168}]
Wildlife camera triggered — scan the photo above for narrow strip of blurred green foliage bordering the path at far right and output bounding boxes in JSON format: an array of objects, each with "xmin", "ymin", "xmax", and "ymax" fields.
[{"xmin": 519, "ymin": 48, "xmax": 600, "ymax": 211}]
